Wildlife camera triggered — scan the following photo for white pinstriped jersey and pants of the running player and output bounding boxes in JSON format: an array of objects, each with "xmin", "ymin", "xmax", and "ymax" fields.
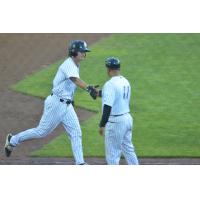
[{"xmin": 10, "ymin": 58, "xmax": 84, "ymax": 164}]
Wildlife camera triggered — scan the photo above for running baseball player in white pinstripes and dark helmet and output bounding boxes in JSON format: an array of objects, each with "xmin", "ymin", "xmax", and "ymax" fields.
[{"xmin": 4, "ymin": 40, "xmax": 97, "ymax": 165}]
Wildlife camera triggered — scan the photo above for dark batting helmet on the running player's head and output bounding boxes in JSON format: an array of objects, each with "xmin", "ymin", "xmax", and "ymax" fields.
[{"xmin": 68, "ymin": 40, "xmax": 90, "ymax": 56}]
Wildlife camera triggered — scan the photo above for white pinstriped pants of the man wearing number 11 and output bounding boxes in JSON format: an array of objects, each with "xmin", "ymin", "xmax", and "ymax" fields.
[{"xmin": 105, "ymin": 113, "xmax": 139, "ymax": 165}]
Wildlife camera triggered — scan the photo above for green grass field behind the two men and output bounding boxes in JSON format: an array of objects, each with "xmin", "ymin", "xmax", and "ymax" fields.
[{"xmin": 12, "ymin": 33, "xmax": 200, "ymax": 157}]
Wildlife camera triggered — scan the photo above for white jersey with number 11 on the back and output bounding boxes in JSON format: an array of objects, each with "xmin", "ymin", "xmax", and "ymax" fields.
[{"xmin": 102, "ymin": 76, "xmax": 131, "ymax": 115}]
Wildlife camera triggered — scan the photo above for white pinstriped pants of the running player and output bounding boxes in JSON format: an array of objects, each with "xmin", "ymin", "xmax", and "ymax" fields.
[{"xmin": 10, "ymin": 95, "xmax": 84, "ymax": 164}]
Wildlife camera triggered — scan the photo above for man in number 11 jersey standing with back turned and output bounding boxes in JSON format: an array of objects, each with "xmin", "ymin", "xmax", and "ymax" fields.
[{"xmin": 99, "ymin": 57, "xmax": 139, "ymax": 165}]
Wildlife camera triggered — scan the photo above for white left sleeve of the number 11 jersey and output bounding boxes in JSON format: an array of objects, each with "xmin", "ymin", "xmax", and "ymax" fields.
[{"xmin": 102, "ymin": 82, "xmax": 115, "ymax": 107}]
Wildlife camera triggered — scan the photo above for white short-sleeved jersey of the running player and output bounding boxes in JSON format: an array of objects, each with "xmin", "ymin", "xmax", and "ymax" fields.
[{"xmin": 52, "ymin": 57, "xmax": 79, "ymax": 100}]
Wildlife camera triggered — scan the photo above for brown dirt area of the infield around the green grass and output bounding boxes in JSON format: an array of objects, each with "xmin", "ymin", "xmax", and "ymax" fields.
[{"xmin": 0, "ymin": 33, "xmax": 200, "ymax": 164}]
